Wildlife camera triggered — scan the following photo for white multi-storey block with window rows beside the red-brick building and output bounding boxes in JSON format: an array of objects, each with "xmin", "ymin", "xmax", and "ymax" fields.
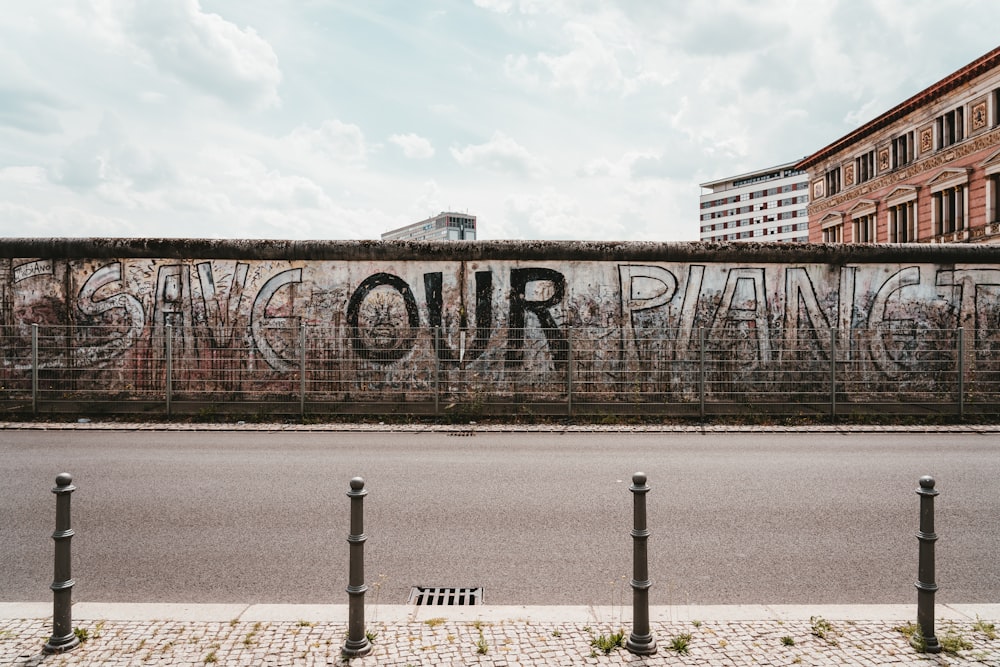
[{"xmin": 699, "ymin": 162, "xmax": 809, "ymax": 243}]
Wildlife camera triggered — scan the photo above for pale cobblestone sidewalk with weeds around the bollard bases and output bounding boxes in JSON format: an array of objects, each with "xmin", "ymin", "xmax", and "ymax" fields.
[{"xmin": 0, "ymin": 618, "xmax": 1000, "ymax": 667}]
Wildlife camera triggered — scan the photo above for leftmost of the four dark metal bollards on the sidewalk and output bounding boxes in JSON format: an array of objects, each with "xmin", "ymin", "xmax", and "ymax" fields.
[{"xmin": 42, "ymin": 472, "xmax": 80, "ymax": 653}]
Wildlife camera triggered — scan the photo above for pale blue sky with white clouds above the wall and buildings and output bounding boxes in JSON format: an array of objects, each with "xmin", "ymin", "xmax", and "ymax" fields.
[{"xmin": 0, "ymin": 0, "xmax": 1000, "ymax": 241}]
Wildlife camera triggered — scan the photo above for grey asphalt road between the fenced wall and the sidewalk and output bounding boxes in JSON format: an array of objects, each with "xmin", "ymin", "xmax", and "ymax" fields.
[{"xmin": 0, "ymin": 430, "xmax": 1000, "ymax": 605}]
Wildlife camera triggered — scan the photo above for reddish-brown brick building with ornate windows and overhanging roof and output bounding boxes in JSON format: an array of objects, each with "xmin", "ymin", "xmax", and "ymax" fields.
[{"xmin": 796, "ymin": 48, "xmax": 1000, "ymax": 243}]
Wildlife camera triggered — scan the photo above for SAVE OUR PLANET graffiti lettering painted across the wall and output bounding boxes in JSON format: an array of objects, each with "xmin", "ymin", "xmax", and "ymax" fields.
[{"xmin": 0, "ymin": 258, "xmax": 1000, "ymax": 386}]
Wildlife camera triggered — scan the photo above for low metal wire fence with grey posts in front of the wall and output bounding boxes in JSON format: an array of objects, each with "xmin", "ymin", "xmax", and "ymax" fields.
[{"xmin": 0, "ymin": 322, "xmax": 1000, "ymax": 419}]
